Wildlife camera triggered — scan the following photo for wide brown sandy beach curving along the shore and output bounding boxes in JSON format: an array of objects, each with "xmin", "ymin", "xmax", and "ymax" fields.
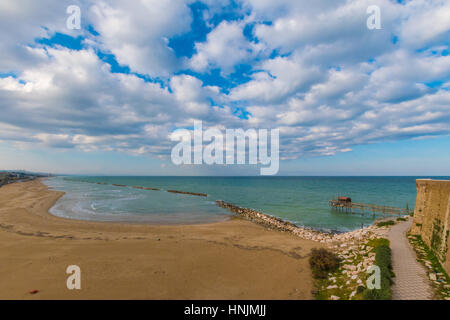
[{"xmin": 0, "ymin": 180, "xmax": 320, "ymax": 299}]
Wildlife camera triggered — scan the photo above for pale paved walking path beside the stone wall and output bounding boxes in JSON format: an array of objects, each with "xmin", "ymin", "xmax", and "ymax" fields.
[{"xmin": 388, "ymin": 219, "xmax": 433, "ymax": 300}]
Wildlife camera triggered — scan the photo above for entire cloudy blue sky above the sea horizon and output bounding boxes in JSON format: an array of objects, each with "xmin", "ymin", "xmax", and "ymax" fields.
[{"xmin": 0, "ymin": 0, "xmax": 450, "ymax": 175}]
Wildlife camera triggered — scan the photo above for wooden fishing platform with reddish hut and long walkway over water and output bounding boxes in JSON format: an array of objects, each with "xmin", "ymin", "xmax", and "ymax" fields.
[{"xmin": 329, "ymin": 197, "xmax": 410, "ymax": 216}]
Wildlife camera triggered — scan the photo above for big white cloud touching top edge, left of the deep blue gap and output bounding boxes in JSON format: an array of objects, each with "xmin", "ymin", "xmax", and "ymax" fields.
[{"xmin": 90, "ymin": 0, "xmax": 192, "ymax": 78}]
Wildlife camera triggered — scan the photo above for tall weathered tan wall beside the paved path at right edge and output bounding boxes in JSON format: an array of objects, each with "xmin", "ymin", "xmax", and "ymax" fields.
[{"xmin": 411, "ymin": 179, "xmax": 450, "ymax": 273}]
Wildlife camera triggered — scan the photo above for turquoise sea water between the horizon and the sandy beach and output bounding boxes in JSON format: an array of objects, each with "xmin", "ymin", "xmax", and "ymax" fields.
[{"xmin": 45, "ymin": 177, "xmax": 449, "ymax": 231}]
